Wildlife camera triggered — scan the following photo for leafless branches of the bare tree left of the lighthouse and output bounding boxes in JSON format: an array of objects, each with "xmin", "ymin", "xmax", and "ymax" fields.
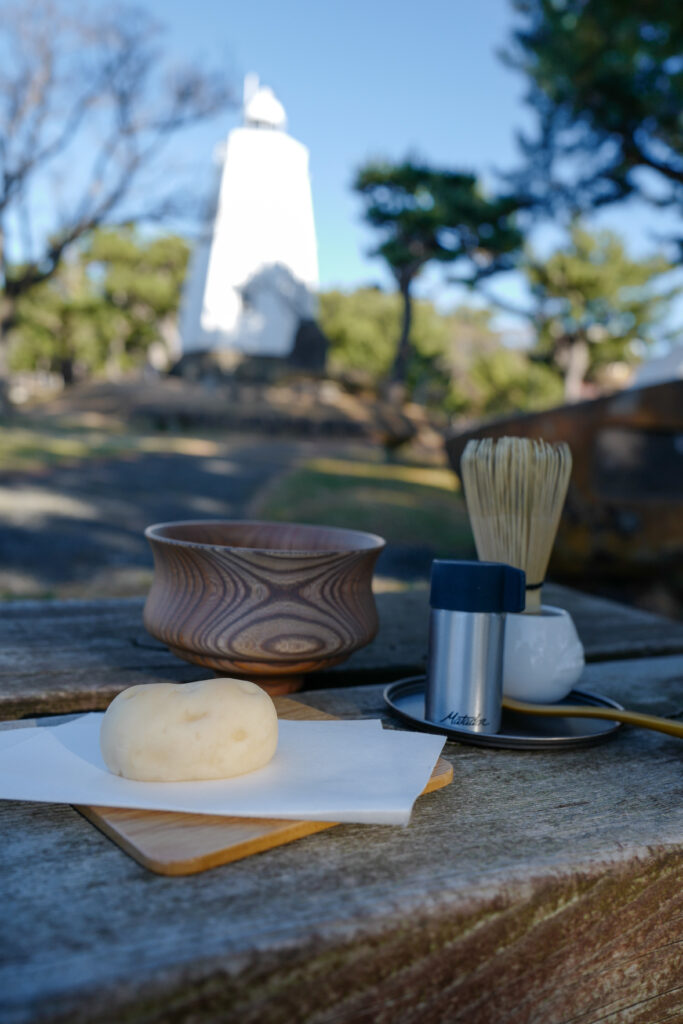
[{"xmin": 0, "ymin": 0, "xmax": 233, "ymax": 326}]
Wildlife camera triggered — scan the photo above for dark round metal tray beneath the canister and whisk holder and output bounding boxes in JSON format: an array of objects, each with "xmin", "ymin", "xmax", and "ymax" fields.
[{"xmin": 384, "ymin": 676, "xmax": 623, "ymax": 751}]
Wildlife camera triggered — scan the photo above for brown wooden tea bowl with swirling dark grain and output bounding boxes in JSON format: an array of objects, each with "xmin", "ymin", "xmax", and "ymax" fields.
[{"xmin": 143, "ymin": 520, "xmax": 385, "ymax": 694}]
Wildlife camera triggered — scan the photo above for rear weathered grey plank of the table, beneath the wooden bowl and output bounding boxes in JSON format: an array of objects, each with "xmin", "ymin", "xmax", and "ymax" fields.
[{"xmin": 0, "ymin": 586, "xmax": 683, "ymax": 719}]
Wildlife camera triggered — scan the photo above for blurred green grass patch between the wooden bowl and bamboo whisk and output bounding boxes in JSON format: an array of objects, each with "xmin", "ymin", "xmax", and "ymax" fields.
[{"xmin": 253, "ymin": 458, "xmax": 474, "ymax": 557}]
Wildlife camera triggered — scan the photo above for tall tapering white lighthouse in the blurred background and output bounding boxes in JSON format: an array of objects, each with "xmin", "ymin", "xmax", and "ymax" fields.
[{"xmin": 179, "ymin": 75, "xmax": 317, "ymax": 357}]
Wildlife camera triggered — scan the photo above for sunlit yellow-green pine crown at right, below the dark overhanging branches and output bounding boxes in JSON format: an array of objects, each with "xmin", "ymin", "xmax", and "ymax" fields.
[{"xmin": 525, "ymin": 222, "xmax": 678, "ymax": 389}]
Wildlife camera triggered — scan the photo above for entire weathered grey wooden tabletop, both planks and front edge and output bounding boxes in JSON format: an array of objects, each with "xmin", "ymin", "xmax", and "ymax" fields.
[{"xmin": 0, "ymin": 588, "xmax": 683, "ymax": 1024}]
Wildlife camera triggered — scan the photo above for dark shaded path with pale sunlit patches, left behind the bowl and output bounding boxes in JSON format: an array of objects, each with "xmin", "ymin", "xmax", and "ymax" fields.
[{"xmin": 0, "ymin": 439, "xmax": 310, "ymax": 597}]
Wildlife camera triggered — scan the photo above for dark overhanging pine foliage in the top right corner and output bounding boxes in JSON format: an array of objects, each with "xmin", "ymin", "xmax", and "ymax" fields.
[{"xmin": 508, "ymin": 0, "xmax": 683, "ymax": 216}]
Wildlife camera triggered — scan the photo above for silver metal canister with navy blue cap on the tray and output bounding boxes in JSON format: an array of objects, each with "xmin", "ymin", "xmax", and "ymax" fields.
[{"xmin": 425, "ymin": 559, "xmax": 525, "ymax": 733}]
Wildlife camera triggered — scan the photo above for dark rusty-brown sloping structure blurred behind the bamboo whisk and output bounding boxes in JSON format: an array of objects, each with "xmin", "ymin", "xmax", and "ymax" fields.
[{"xmin": 445, "ymin": 380, "xmax": 683, "ymax": 586}]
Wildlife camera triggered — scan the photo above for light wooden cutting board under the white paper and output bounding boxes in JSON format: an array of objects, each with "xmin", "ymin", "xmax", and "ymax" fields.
[{"xmin": 77, "ymin": 697, "xmax": 453, "ymax": 874}]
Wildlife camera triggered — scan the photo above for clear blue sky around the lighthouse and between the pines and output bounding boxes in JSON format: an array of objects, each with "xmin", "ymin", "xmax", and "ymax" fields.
[{"xmin": 18, "ymin": 0, "xmax": 683, "ymax": 344}]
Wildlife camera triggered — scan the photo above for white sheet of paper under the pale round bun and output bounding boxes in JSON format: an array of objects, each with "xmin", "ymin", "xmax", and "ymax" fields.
[{"xmin": 0, "ymin": 713, "xmax": 445, "ymax": 824}]
